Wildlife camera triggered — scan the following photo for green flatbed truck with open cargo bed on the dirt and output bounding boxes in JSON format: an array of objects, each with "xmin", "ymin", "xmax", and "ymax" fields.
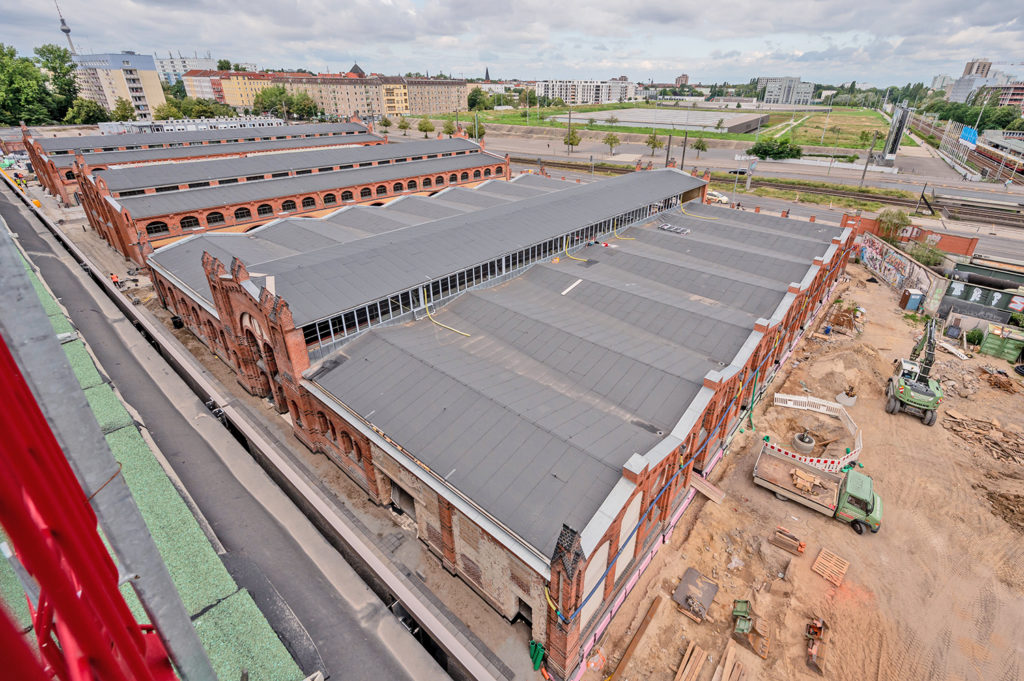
[{"xmin": 754, "ymin": 443, "xmax": 882, "ymax": 535}]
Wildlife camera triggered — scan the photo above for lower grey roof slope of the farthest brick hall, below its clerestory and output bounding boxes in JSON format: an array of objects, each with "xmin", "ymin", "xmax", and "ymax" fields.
[{"xmin": 76, "ymin": 134, "xmax": 384, "ymax": 166}]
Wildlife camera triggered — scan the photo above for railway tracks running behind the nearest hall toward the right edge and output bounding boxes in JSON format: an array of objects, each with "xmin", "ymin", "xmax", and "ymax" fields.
[{"xmin": 510, "ymin": 157, "xmax": 1024, "ymax": 227}]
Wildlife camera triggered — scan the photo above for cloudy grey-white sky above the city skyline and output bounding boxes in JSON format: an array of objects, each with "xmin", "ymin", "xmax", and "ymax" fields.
[{"xmin": 8, "ymin": 0, "xmax": 1024, "ymax": 86}]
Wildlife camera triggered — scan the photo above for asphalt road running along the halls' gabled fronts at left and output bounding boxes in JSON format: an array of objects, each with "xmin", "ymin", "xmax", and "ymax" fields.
[{"xmin": 0, "ymin": 186, "xmax": 446, "ymax": 681}]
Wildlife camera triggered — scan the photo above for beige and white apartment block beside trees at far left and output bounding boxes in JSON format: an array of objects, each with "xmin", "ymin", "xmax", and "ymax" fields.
[{"xmin": 72, "ymin": 52, "xmax": 165, "ymax": 121}]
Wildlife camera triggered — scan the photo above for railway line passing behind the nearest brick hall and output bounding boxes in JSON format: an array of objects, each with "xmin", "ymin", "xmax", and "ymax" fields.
[{"xmin": 510, "ymin": 157, "xmax": 1024, "ymax": 227}]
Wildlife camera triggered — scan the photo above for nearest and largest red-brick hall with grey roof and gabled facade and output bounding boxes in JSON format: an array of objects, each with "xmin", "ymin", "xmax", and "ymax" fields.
[{"xmin": 147, "ymin": 169, "xmax": 853, "ymax": 679}]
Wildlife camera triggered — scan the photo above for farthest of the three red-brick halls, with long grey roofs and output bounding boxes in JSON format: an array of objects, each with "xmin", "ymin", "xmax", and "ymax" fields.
[{"xmin": 22, "ymin": 122, "xmax": 376, "ymax": 206}]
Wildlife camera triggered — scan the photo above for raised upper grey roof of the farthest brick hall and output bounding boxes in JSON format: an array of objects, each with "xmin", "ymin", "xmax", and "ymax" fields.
[{"xmin": 35, "ymin": 123, "xmax": 367, "ymax": 152}]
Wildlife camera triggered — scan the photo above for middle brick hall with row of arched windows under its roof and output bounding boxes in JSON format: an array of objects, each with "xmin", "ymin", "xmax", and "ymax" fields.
[{"xmin": 75, "ymin": 138, "xmax": 508, "ymax": 264}]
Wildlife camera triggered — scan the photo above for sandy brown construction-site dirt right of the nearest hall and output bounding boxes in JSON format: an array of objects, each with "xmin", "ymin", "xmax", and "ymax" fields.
[{"xmin": 584, "ymin": 264, "xmax": 1024, "ymax": 681}]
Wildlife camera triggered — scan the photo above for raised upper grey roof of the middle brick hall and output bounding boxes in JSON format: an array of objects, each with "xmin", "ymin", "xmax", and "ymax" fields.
[{"xmin": 96, "ymin": 138, "xmax": 480, "ymax": 191}]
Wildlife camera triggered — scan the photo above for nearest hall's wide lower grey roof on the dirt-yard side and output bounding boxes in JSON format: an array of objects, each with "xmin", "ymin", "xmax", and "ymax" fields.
[{"xmin": 307, "ymin": 199, "xmax": 841, "ymax": 555}]
